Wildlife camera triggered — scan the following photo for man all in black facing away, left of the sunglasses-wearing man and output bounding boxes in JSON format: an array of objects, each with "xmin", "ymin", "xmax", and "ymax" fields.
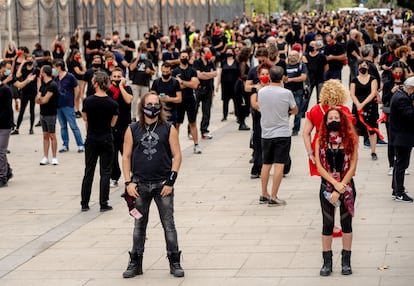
[{"xmin": 81, "ymin": 72, "xmax": 119, "ymax": 212}]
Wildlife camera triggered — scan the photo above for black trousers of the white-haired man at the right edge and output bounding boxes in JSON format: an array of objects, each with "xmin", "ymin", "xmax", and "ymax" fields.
[{"xmin": 392, "ymin": 146, "xmax": 412, "ymax": 196}]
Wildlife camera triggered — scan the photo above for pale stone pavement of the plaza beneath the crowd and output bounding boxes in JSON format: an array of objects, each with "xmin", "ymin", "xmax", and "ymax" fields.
[{"xmin": 0, "ymin": 81, "xmax": 414, "ymax": 286}]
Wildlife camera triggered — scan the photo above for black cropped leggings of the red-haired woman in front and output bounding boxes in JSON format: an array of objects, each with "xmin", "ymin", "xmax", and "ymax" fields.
[{"xmin": 319, "ymin": 180, "xmax": 356, "ymax": 235}]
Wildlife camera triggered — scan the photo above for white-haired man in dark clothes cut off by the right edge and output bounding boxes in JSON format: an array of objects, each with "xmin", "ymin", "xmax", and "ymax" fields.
[{"xmin": 389, "ymin": 76, "xmax": 414, "ymax": 203}]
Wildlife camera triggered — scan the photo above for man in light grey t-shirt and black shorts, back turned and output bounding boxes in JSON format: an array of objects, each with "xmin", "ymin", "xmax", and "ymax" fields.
[{"xmin": 258, "ymin": 66, "xmax": 298, "ymax": 207}]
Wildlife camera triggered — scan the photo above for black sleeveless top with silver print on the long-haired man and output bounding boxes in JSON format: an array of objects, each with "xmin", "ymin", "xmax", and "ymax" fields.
[{"xmin": 130, "ymin": 122, "xmax": 172, "ymax": 183}]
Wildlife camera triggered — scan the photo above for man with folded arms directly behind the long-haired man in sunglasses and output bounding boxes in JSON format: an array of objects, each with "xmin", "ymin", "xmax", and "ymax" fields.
[{"xmin": 151, "ymin": 63, "xmax": 182, "ymax": 126}]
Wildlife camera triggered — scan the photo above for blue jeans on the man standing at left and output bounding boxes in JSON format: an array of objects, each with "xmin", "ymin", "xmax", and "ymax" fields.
[{"xmin": 58, "ymin": 106, "xmax": 83, "ymax": 148}]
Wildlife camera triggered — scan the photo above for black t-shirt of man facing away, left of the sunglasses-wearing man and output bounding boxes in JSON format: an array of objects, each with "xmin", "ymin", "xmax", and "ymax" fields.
[{"xmin": 82, "ymin": 95, "xmax": 119, "ymax": 142}]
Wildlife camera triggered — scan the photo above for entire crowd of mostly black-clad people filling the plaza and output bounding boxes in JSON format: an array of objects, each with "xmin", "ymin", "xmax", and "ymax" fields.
[{"xmin": 0, "ymin": 6, "xmax": 414, "ymax": 278}]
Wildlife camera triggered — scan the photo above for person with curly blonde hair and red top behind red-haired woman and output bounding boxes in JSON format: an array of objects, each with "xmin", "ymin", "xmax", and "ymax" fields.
[{"xmin": 303, "ymin": 79, "xmax": 355, "ymax": 176}]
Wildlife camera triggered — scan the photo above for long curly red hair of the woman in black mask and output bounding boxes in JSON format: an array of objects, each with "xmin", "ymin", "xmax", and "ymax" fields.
[{"xmin": 319, "ymin": 107, "xmax": 358, "ymax": 155}]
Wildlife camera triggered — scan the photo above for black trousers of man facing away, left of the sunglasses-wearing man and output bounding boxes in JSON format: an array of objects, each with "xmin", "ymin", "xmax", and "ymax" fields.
[{"xmin": 81, "ymin": 138, "xmax": 114, "ymax": 207}]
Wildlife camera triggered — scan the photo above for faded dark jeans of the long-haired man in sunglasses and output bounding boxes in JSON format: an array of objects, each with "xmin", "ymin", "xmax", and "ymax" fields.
[{"xmin": 132, "ymin": 182, "xmax": 178, "ymax": 254}]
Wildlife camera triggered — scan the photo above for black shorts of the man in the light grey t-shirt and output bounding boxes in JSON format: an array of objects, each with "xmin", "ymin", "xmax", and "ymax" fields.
[{"xmin": 262, "ymin": 137, "xmax": 291, "ymax": 165}]
